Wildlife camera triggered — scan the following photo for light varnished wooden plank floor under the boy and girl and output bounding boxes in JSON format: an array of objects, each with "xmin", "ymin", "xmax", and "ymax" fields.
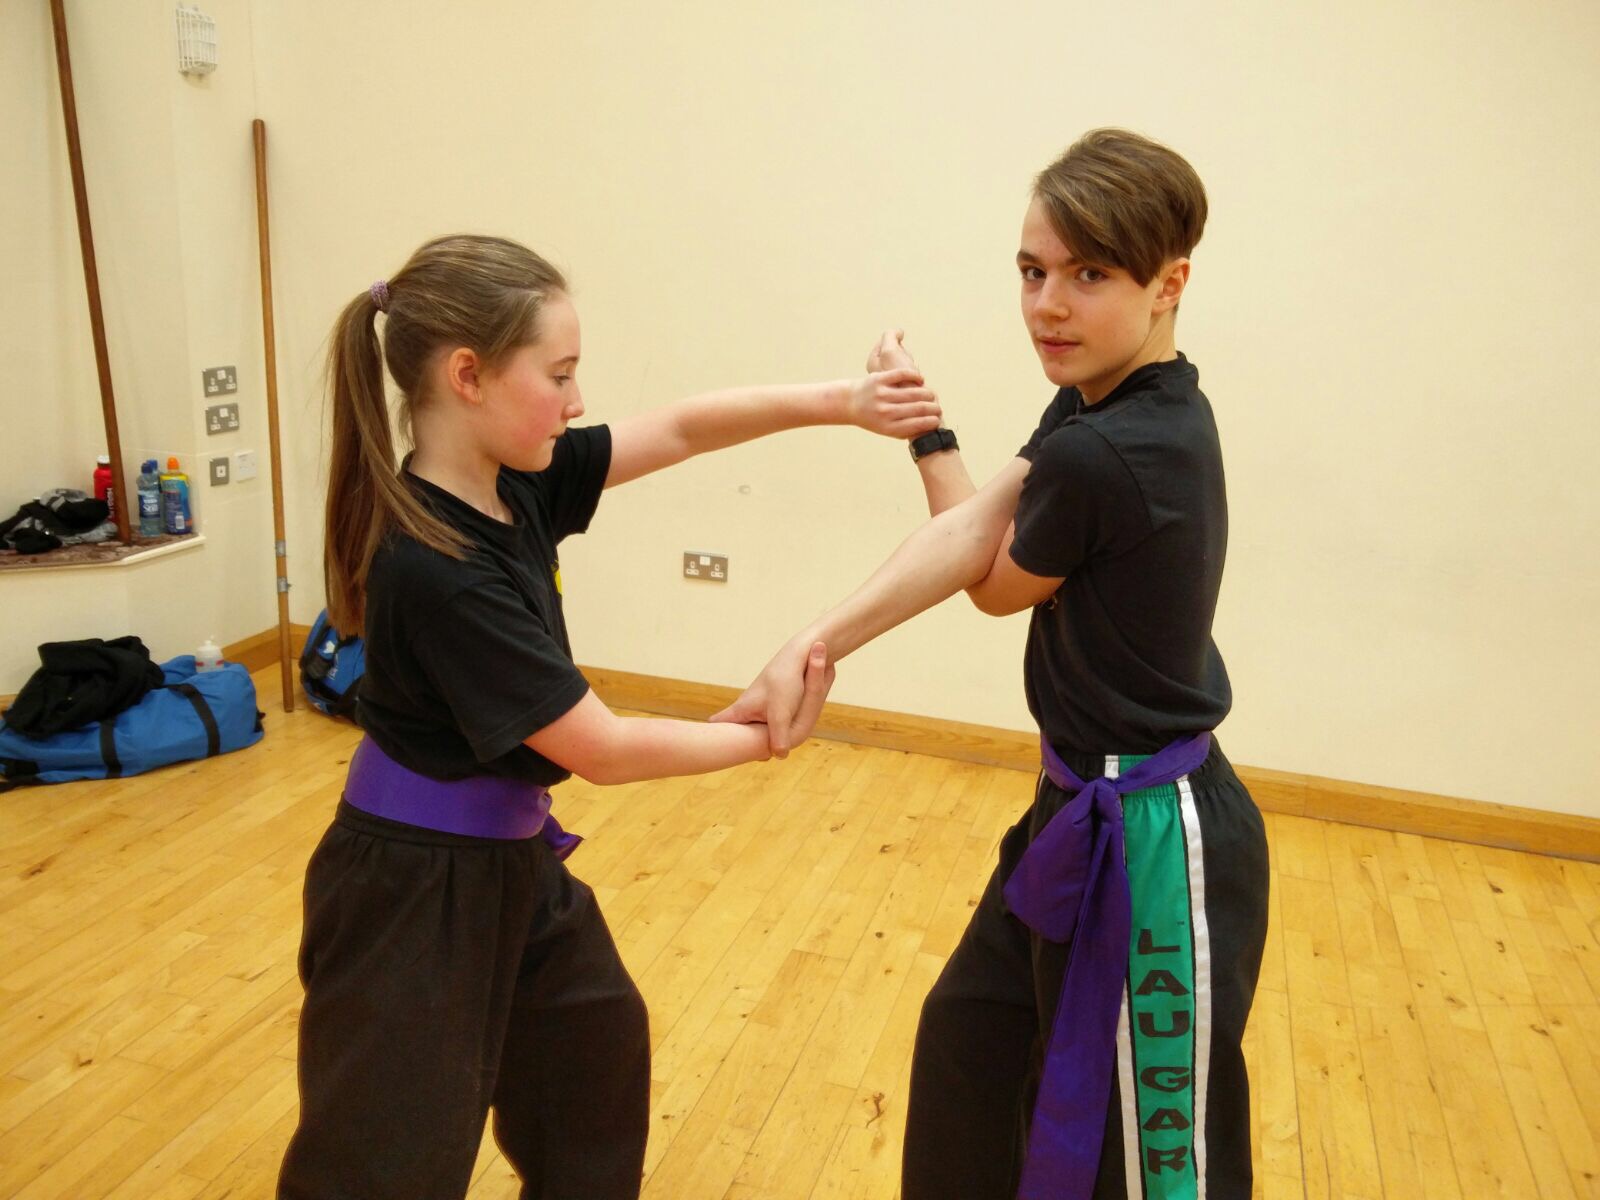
[{"xmin": 0, "ymin": 670, "xmax": 1600, "ymax": 1200}]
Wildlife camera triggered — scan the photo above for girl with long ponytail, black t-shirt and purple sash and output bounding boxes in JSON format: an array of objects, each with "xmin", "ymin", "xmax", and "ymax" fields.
[{"xmin": 278, "ymin": 237, "xmax": 939, "ymax": 1200}]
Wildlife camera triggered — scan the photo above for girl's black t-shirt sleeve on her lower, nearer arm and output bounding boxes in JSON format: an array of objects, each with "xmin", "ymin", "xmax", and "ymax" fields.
[{"xmin": 411, "ymin": 582, "xmax": 589, "ymax": 763}]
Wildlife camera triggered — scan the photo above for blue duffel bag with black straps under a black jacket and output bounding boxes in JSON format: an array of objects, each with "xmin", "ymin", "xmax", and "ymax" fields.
[{"xmin": 0, "ymin": 654, "xmax": 262, "ymax": 787}]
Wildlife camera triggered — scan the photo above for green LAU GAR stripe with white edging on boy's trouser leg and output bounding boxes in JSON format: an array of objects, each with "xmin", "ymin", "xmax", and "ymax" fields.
[{"xmin": 1118, "ymin": 755, "xmax": 1198, "ymax": 1200}]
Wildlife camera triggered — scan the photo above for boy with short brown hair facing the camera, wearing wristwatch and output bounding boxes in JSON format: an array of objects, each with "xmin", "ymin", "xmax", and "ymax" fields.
[{"xmin": 718, "ymin": 130, "xmax": 1267, "ymax": 1200}]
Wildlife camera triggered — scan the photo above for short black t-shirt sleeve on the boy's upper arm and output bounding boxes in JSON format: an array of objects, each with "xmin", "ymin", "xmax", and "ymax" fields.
[{"xmin": 1011, "ymin": 425, "xmax": 1149, "ymax": 579}]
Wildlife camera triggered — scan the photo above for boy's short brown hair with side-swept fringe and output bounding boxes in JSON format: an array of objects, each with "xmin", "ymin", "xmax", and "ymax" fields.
[{"xmin": 1034, "ymin": 130, "xmax": 1206, "ymax": 285}]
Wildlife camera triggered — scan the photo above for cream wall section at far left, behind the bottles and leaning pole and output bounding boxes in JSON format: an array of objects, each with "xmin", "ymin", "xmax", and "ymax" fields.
[{"xmin": 0, "ymin": 0, "xmax": 277, "ymax": 693}]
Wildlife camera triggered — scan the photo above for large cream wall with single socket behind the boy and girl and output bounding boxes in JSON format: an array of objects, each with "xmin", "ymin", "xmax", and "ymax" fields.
[{"xmin": 15, "ymin": 0, "xmax": 1600, "ymax": 816}]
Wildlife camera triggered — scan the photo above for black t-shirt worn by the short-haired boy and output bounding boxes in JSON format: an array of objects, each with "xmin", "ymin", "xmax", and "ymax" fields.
[{"xmin": 1011, "ymin": 355, "xmax": 1232, "ymax": 755}]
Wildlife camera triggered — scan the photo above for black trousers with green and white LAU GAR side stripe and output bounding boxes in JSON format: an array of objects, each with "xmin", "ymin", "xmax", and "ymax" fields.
[{"xmin": 901, "ymin": 742, "xmax": 1269, "ymax": 1200}]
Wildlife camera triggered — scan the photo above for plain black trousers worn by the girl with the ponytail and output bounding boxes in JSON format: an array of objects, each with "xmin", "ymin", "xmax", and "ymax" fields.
[{"xmin": 278, "ymin": 803, "xmax": 650, "ymax": 1200}]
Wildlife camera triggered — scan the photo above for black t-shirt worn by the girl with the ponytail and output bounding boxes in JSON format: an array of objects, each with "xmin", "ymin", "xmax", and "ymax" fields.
[{"xmin": 360, "ymin": 426, "xmax": 611, "ymax": 787}]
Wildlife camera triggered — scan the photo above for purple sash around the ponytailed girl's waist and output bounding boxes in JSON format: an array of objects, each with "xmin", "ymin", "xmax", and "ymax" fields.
[{"xmin": 344, "ymin": 738, "xmax": 582, "ymax": 858}]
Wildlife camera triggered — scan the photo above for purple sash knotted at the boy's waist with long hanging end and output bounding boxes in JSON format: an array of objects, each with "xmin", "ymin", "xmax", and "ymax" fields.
[{"xmin": 1005, "ymin": 733, "xmax": 1211, "ymax": 1200}]
